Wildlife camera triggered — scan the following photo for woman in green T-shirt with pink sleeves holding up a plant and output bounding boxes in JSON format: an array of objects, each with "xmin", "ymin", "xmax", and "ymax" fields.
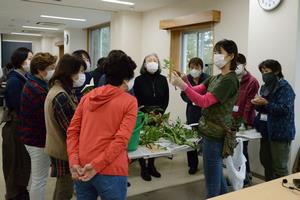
[{"xmin": 171, "ymin": 39, "xmax": 239, "ymax": 198}]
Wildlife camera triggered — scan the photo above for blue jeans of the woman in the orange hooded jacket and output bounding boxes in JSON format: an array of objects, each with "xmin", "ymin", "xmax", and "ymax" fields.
[{"xmin": 75, "ymin": 174, "xmax": 127, "ymax": 200}]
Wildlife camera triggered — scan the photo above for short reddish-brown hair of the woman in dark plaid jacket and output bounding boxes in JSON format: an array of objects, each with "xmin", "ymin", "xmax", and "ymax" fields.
[{"xmin": 30, "ymin": 53, "xmax": 57, "ymax": 75}]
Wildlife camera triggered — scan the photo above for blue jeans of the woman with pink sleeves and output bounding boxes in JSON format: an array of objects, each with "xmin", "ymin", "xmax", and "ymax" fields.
[{"xmin": 202, "ymin": 137, "xmax": 228, "ymax": 198}]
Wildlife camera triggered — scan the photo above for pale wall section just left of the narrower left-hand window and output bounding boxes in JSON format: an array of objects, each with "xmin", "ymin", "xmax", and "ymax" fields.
[{"xmin": 64, "ymin": 29, "xmax": 87, "ymax": 53}]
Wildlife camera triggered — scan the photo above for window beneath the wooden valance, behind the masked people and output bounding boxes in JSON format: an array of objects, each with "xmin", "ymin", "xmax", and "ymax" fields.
[{"xmin": 181, "ymin": 30, "xmax": 213, "ymax": 74}]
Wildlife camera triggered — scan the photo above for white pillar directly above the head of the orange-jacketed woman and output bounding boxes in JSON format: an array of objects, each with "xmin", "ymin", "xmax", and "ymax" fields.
[{"xmin": 110, "ymin": 12, "xmax": 142, "ymax": 69}]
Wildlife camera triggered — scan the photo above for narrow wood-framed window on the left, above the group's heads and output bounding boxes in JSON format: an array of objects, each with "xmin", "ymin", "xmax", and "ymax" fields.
[{"xmin": 90, "ymin": 26, "xmax": 110, "ymax": 66}]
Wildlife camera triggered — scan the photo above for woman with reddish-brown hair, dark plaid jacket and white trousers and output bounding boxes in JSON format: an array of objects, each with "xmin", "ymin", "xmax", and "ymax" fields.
[{"xmin": 18, "ymin": 53, "xmax": 57, "ymax": 200}]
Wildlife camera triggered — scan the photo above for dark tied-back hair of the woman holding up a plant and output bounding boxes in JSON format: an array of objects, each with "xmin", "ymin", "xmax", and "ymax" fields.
[{"xmin": 214, "ymin": 39, "xmax": 238, "ymax": 70}]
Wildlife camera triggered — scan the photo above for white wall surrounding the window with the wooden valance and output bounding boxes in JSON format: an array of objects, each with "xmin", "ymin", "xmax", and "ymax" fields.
[{"xmin": 141, "ymin": 0, "xmax": 249, "ymax": 121}]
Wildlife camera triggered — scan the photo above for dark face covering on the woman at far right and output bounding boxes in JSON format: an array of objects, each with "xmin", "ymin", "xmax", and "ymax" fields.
[{"xmin": 260, "ymin": 72, "xmax": 279, "ymax": 97}]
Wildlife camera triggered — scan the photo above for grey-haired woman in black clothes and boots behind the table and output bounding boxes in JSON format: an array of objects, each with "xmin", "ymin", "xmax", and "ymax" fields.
[{"xmin": 133, "ymin": 53, "xmax": 169, "ymax": 181}]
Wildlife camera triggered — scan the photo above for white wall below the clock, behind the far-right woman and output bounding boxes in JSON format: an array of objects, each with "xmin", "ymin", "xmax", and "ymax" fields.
[{"xmin": 248, "ymin": 0, "xmax": 300, "ymax": 174}]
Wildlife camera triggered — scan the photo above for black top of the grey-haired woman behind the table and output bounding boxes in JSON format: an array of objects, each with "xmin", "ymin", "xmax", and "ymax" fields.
[{"xmin": 133, "ymin": 73, "xmax": 169, "ymax": 112}]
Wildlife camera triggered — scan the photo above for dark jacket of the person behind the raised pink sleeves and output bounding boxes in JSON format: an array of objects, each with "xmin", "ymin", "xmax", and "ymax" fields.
[{"xmin": 180, "ymin": 73, "xmax": 209, "ymax": 124}]
